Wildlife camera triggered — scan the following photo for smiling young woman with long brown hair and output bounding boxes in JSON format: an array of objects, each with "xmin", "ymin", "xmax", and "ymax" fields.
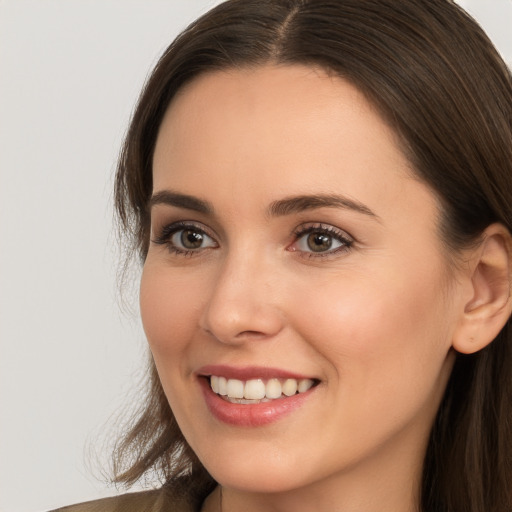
[{"xmin": 53, "ymin": 0, "xmax": 512, "ymax": 512}]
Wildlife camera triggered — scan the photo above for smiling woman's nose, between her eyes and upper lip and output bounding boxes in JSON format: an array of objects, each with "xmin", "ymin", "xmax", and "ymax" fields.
[{"xmin": 200, "ymin": 254, "xmax": 284, "ymax": 344}]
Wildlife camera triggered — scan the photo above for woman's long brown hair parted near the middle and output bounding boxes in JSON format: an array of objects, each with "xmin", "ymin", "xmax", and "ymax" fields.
[{"xmin": 115, "ymin": 0, "xmax": 512, "ymax": 512}]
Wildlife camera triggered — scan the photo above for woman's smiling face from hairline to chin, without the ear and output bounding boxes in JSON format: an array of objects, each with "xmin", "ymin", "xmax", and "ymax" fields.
[{"xmin": 141, "ymin": 66, "xmax": 462, "ymax": 500}]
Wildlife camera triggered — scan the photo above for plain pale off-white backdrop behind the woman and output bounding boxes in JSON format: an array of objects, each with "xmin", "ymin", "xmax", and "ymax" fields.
[{"xmin": 0, "ymin": 0, "xmax": 512, "ymax": 512}]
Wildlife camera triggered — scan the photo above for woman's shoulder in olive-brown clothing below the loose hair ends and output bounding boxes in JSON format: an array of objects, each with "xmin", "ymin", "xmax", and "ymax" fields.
[{"xmin": 48, "ymin": 488, "xmax": 194, "ymax": 512}]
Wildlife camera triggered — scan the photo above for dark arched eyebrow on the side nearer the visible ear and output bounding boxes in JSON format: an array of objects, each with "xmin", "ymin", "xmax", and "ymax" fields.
[{"xmin": 268, "ymin": 194, "xmax": 380, "ymax": 220}]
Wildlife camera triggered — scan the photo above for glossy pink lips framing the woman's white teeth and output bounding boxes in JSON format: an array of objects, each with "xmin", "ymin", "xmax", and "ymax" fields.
[{"xmin": 197, "ymin": 365, "xmax": 316, "ymax": 427}]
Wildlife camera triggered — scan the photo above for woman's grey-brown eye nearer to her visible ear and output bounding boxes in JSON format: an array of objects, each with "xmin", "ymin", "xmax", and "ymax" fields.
[{"xmin": 289, "ymin": 224, "xmax": 354, "ymax": 256}]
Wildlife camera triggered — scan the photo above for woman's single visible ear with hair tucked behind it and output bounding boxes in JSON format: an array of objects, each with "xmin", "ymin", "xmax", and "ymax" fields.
[{"xmin": 452, "ymin": 224, "xmax": 512, "ymax": 354}]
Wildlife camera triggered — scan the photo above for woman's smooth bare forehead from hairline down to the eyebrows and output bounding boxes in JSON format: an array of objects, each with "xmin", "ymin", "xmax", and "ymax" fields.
[{"xmin": 153, "ymin": 66, "xmax": 435, "ymax": 234}]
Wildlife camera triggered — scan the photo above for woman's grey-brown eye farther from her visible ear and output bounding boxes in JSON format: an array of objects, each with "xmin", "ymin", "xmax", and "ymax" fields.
[{"xmin": 153, "ymin": 222, "xmax": 217, "ymax": 255}]
